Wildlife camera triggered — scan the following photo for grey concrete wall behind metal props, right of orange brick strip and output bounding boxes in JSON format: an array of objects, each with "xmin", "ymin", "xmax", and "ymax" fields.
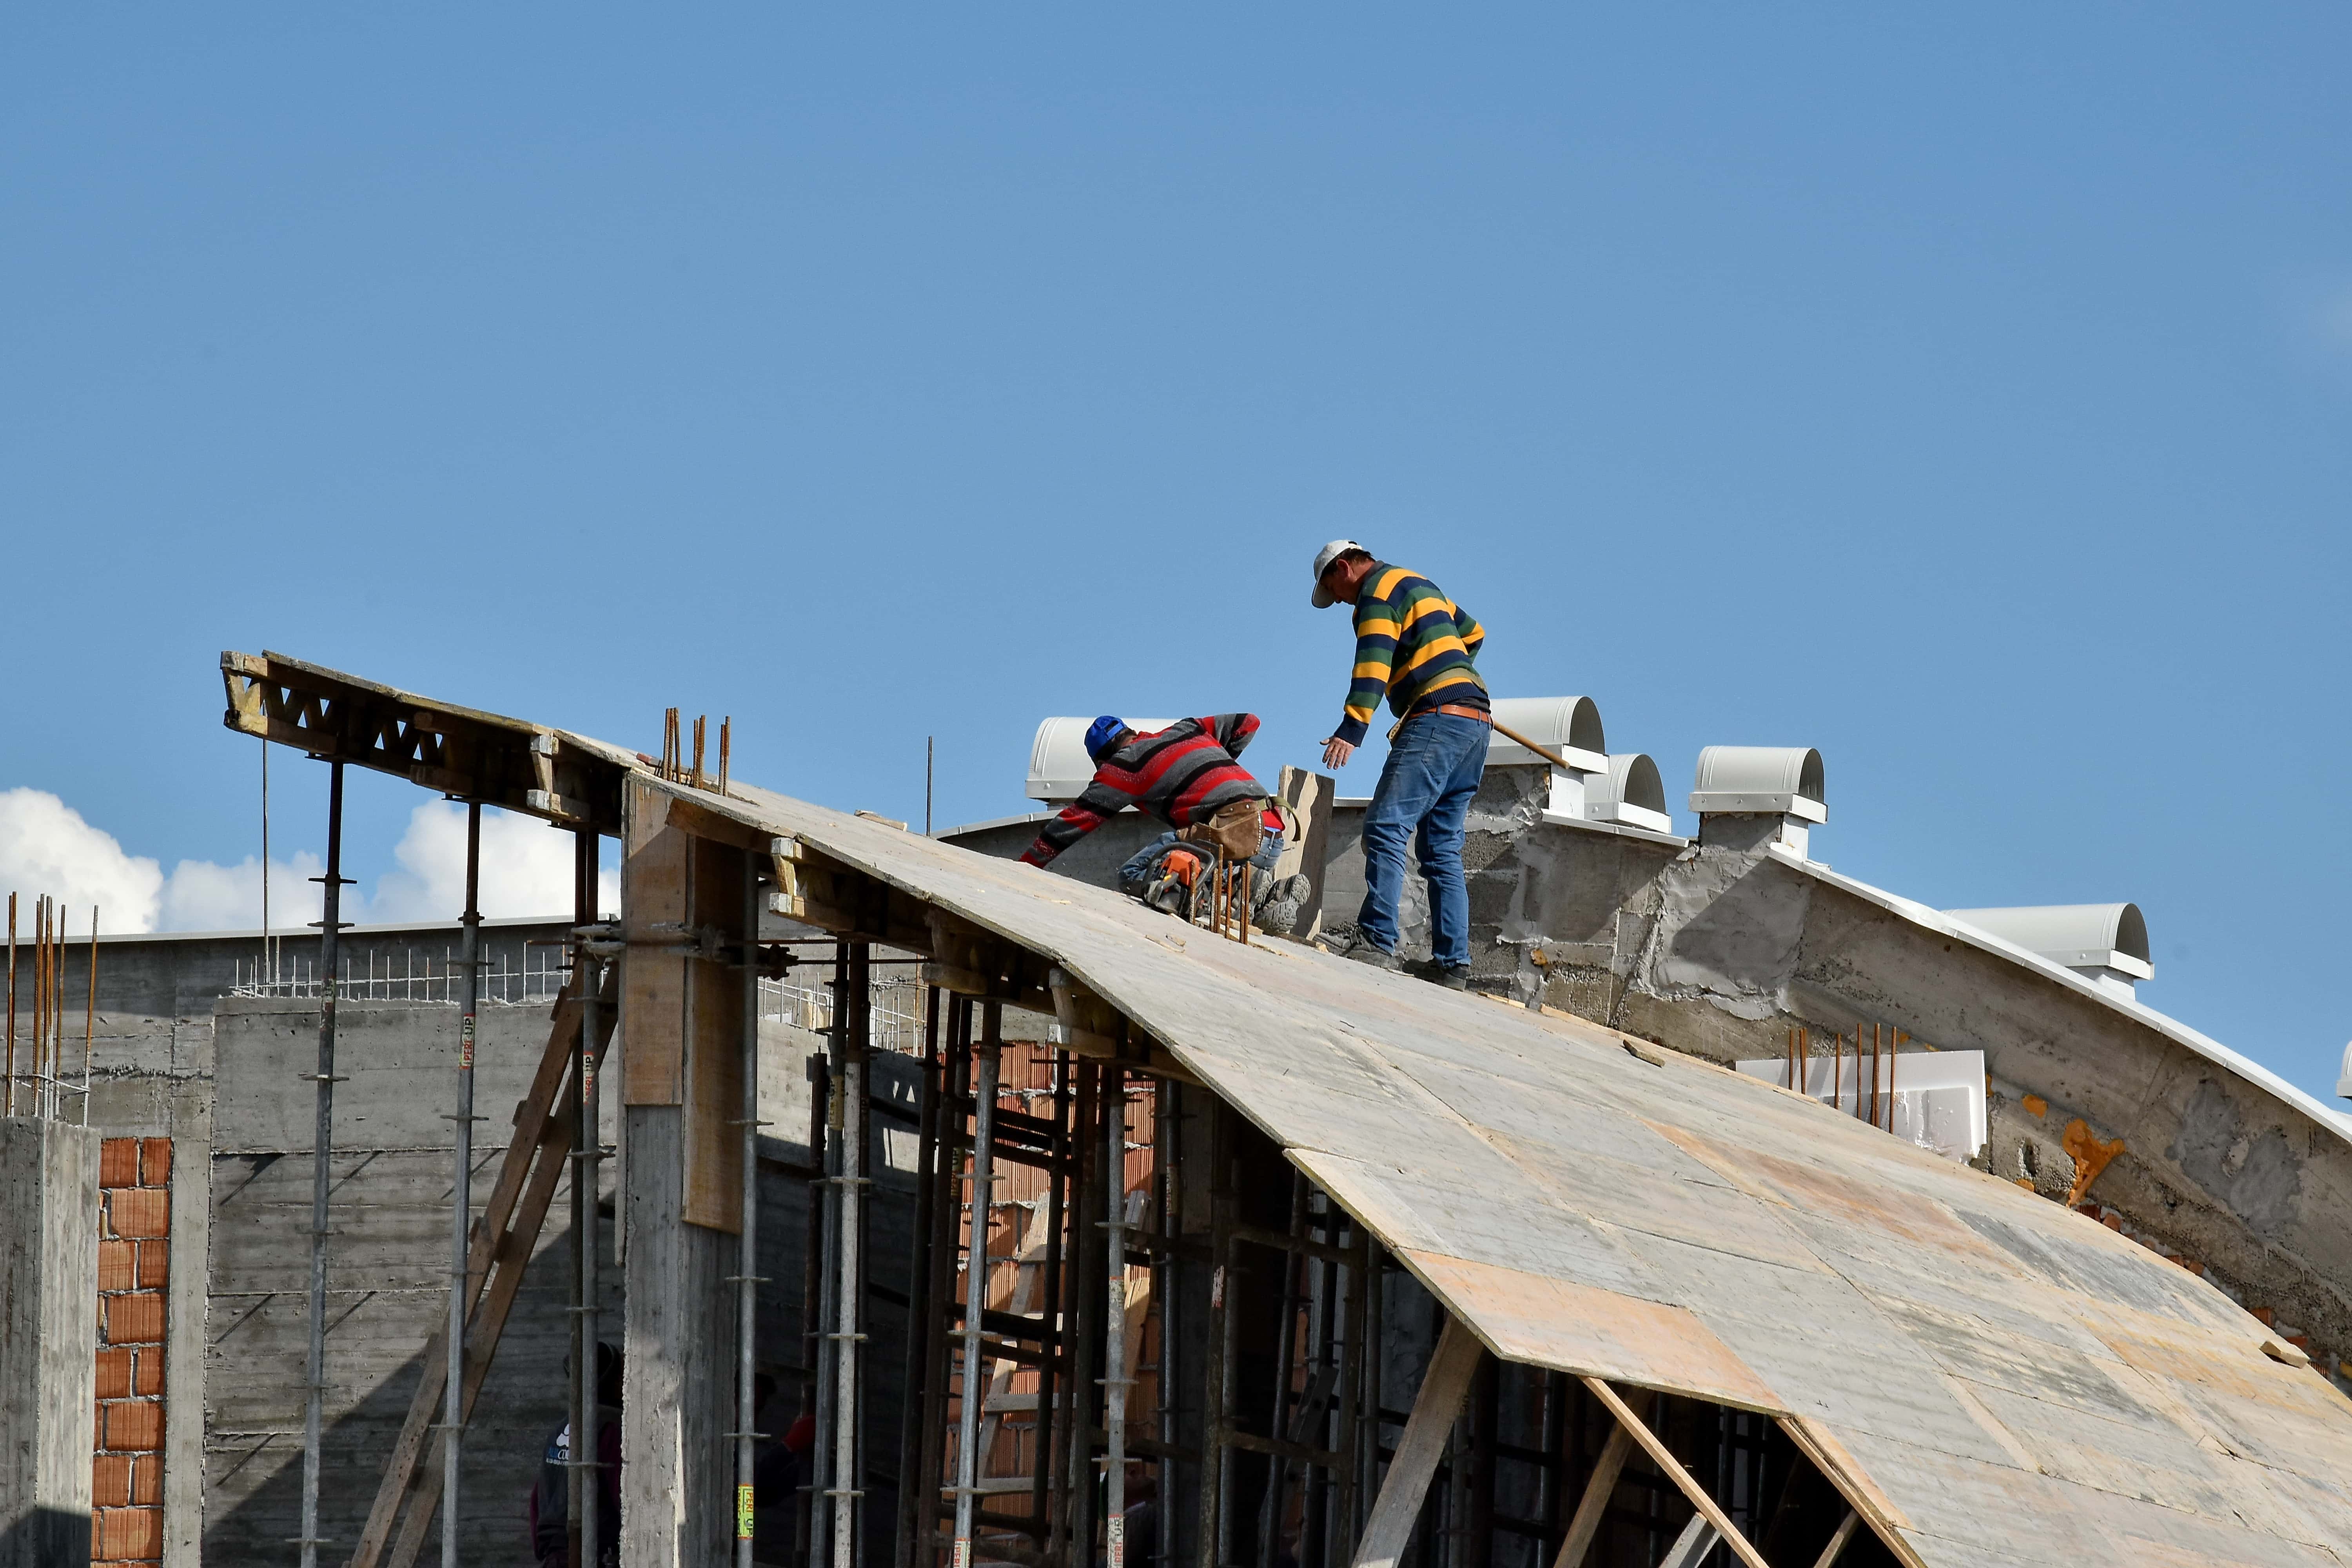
[{"xmin": 202, "ymin": 999, "xmax": 621, "ymax": 1563}]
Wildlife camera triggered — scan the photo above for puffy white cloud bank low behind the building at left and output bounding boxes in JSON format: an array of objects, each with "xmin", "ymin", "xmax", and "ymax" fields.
[{"xmin": 0, "ymin": 788, "xmax": 621, "ymax": 933}]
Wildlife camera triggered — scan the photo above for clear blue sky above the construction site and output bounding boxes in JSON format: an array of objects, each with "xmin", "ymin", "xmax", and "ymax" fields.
[{"xmin": 0, "ymin": 5, "xmax": 2352, "ymax": 1093}]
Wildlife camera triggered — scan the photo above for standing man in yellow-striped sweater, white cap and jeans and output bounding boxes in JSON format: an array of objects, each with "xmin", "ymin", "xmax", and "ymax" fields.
[{"xmin": 1312, "ymin": 538, "xmax": 1494, "ymax": 990}]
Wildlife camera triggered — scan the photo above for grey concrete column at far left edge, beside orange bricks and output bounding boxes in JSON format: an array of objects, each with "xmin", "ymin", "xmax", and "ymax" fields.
[{"xmin": 0, "ymin": 1117, "xmax": 99, "ymax": 1568}]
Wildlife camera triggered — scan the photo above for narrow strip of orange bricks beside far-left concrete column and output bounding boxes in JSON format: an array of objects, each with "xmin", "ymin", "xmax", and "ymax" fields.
[{"xmin": 89, "ymin": 1138, "xmax": 172, "ymax": 1563}]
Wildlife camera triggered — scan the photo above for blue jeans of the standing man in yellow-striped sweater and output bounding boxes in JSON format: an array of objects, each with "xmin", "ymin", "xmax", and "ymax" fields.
[{"xmin": 1355, "ymin": 712, "xmax": 1491, "ymax": 969}]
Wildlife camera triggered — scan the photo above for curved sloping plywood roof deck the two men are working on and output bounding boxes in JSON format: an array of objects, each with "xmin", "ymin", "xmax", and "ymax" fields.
[{"xmin": 661, "ymin": 785, "xmax": 2352, "ymax": 1568}]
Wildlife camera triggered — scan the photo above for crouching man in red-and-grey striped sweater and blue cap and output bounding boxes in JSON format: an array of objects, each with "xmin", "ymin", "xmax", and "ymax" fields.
[{"xmin": 1021, "ymin": 712, "xmax": 1282, "ymax": 900}]
